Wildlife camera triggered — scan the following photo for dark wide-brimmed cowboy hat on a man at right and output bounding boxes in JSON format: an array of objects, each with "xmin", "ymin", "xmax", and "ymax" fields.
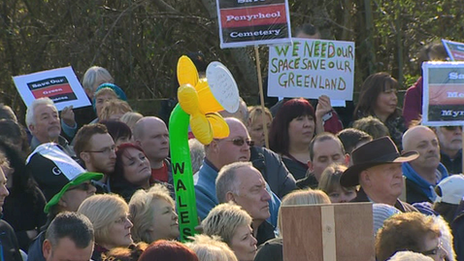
[{"xmin": 340, "ymin": 137, "xmax": 419, "ymax": 187}]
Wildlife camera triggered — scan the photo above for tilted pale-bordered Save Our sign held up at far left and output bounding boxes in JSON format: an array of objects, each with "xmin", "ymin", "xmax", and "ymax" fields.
[{"xmin": 13, "ymin": 67, "xmax": 91, "ymax": 111}]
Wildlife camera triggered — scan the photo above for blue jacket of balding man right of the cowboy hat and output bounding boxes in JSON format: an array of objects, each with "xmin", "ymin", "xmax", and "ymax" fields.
[{"xmin": 402, "ymin": 162, "xmax": 448, "ymax": 204}]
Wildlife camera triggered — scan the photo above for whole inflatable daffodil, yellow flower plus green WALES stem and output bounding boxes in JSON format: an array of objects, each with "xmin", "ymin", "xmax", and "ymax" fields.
[{"xmin": 169, "ymin": 56, "xmax": 239, "ymax": 242}]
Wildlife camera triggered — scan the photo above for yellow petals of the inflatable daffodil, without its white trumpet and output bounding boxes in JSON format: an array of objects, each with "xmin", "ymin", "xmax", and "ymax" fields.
[{"xmin": 177, "ymin": 55, "xmax": 238, "ymax": 145}]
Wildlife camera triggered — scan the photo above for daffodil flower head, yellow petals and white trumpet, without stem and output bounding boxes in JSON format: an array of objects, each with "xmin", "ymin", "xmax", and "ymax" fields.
[{"xmin": 177, "ymin": 55, "xmax": 239, "ymax": 145}]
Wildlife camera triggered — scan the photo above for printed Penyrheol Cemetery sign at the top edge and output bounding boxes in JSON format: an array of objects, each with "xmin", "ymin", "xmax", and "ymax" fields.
[{"xmin": 216, "ymin": 0, "xmax": 291, "ymax": 48}]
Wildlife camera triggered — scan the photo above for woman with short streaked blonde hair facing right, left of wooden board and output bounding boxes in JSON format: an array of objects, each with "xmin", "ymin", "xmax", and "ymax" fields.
[{"xmin": 201, "ymin": 203, "xmax": 258, "ymax": 261}]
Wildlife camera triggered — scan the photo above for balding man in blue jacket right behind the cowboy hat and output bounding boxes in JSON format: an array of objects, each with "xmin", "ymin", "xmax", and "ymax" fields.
[{"xmin": 402, "ymin": 125, "xmax": 448, "ymax": 204}]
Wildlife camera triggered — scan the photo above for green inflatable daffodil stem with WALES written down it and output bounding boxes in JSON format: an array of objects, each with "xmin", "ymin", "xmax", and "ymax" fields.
[{"xmin": 169, "ymin": 104, "xmax": 198, "ymax": 242}]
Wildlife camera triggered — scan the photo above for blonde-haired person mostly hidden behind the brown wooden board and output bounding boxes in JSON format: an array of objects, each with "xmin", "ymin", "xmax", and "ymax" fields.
[{"xmin": 254, "ymin": 189, "xmax": 330, "ymax": 261}]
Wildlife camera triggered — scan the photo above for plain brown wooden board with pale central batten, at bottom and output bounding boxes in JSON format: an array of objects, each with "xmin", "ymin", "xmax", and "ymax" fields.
[{"xmin": 281, "ymin": 203, "xmax": 375, "ymax": 261}]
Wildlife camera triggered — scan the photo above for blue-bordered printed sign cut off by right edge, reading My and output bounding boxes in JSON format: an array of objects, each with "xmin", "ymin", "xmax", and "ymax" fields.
[{"xmin": 422, "ymin": 62, "xmax": 464, "ymax": 126}]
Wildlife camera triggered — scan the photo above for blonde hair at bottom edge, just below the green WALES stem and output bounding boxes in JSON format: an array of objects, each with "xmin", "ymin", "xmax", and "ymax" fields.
[{"xmin": 185, "ymin": 235, "xmax": 238, "ymax": 261}]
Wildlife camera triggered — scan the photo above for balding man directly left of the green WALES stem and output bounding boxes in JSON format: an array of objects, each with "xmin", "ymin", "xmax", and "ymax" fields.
[{"xmin": 133, "ymin": 116, "xmax": 173, "ymax": 185}]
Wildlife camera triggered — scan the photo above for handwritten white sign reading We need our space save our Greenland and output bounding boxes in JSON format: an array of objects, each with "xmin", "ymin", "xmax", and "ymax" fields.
[{"xmin": 268, "ymin": 39, "xmax": 355, "ymax": 101}]
